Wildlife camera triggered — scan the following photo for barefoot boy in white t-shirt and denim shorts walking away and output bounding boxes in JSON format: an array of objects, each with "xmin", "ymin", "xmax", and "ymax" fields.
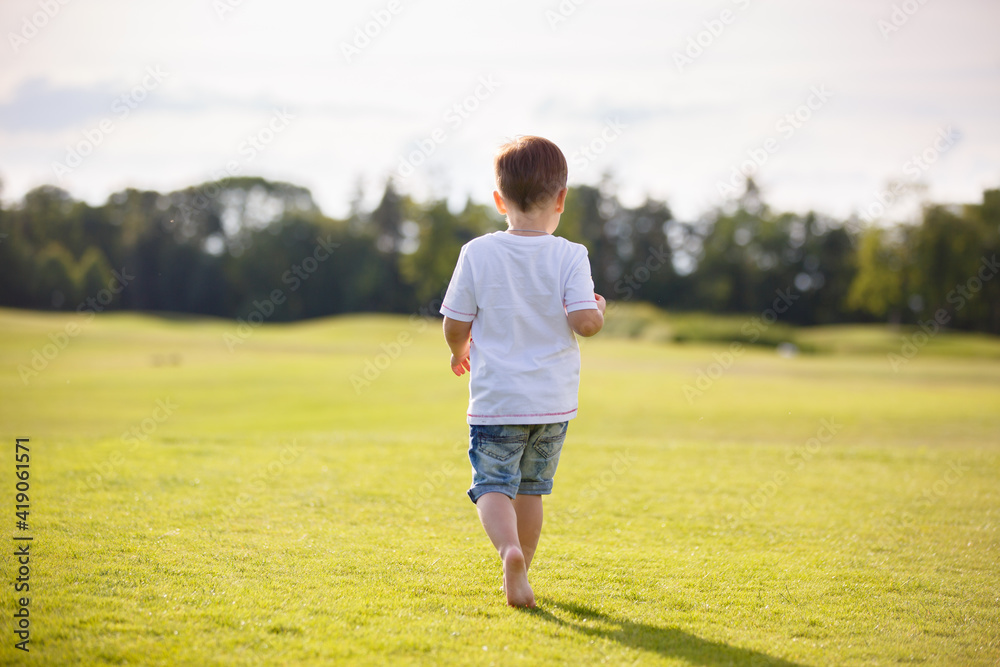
[{"xmin": 441, "ymin": 137, "xmax": 606, "ymax": 607}]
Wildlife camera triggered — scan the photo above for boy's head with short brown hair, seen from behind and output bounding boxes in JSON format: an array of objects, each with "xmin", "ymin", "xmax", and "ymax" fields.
[{"xmin": 493, "ymin": 136, "xmax": 569, "ymax": 213}]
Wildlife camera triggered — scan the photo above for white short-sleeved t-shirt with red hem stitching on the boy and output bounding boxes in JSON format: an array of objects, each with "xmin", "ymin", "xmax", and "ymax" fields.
[{"xmin": 441, "ymin": 232, "xmax": 597, "ymax": 424}]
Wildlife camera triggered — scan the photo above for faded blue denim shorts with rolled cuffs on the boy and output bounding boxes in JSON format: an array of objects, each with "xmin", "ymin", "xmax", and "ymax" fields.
[{"xmin": 469, "ymin": 422, "xmax": 569, "ymax": 503}]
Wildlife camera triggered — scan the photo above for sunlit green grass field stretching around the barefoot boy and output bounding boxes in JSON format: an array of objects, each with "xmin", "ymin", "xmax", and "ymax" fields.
[{"xmin": 0, "ymin": 310, "xmax": 1000, "ymax": 666}]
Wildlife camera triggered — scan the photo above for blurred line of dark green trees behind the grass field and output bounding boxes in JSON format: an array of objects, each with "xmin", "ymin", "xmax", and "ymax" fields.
[{"xmin": 0, "ymin": 177, "xmax": 1000, "ymax": 334}]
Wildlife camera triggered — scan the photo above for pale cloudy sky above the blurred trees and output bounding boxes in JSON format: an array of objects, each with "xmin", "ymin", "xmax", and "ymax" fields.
[{"xmin": 0, "ymin": 0, "xmax": 1000, "ymax": 220}]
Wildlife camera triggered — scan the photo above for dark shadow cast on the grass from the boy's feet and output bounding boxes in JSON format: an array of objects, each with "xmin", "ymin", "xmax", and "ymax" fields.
[{"xmin": 525, "ymin": 599, "xmax": 803, "ymax": 667}]
